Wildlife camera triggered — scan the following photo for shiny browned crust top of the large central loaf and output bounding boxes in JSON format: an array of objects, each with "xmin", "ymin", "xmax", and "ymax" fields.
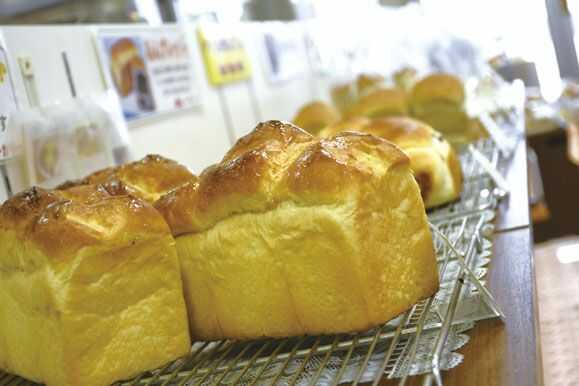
[{"xmin": 155, "ymin": 121, "xmax": 409, "ymax": 235}]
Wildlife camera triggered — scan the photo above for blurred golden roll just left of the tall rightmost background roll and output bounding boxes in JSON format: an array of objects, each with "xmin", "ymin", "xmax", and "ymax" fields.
[{"xmin": 345, "ymin": 88, "xmax": 408, "ymax": 118}]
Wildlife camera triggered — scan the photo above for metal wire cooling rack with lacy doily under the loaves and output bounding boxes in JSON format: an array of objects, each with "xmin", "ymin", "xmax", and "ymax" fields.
[{"xmin": 0, "ymin": 141, "xmax": 502, "ymax": 386}]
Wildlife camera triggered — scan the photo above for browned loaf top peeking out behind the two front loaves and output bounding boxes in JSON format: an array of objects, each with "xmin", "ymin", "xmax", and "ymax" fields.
[{"xmin": 58, "ymin": 154, "xmax": 197, "ymax": 202}]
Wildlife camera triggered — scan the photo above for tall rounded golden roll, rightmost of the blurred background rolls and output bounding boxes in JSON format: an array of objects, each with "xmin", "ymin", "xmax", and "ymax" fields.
[{"xmin": 410, "ymin": 74, "xmax": 469, "ymax": 135}]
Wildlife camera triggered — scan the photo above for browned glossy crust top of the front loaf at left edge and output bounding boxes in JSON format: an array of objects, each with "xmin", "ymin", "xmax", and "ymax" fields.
[{"xmin": 0, "ymin": 185, "xmax": 169, "ymax": 259}]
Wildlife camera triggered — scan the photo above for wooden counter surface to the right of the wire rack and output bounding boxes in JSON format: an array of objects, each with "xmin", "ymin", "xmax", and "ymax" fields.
[{"xmin": 381, "ymin": 141, "xmax": 543, "ymax": 386}]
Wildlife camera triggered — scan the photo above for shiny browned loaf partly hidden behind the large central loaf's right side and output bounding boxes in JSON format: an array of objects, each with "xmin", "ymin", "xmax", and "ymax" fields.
[{"xmin": 320, "ymin": 117, "xmax": 462, "ymax": 208}]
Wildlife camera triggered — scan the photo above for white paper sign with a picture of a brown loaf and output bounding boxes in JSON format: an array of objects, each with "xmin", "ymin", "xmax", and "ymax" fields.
[{"xmin": 99, "ymin": 28, "xmax": 198, "ymax": 120}]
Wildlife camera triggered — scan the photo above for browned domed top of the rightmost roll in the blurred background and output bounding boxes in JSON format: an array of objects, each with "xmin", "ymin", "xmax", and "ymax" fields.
[{"xmin": 410, "ymin": 73, "xmax": 465, "ymax": 106}]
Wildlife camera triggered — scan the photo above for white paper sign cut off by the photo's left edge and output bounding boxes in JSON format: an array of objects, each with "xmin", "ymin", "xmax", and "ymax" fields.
[{"xmin": 0, "ymin": 32, "xmax": 20, "ymax": 161}]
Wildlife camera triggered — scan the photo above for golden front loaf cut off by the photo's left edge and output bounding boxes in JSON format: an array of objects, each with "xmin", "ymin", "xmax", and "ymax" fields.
[{"xmin": 0, "ymin": 186, "xmax": 190, "ymax": 386}]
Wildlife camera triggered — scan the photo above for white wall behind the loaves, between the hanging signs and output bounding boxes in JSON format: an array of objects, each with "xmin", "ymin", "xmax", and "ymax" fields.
[{"xmin": 0, "ymin": 24, "xmax": 320, "ymax": 182}]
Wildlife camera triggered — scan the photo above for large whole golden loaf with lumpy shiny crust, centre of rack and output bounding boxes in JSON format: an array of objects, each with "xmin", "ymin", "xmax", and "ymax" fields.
[{"xmin": 155, "ymin": 121, "xmax": 438, "ymax": 339}]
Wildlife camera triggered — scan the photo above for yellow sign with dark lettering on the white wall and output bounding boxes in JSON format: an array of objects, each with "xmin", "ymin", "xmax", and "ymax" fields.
[{"xmin": 197, "ymin": 24, "xmax": 251, "ymax": 86}]
